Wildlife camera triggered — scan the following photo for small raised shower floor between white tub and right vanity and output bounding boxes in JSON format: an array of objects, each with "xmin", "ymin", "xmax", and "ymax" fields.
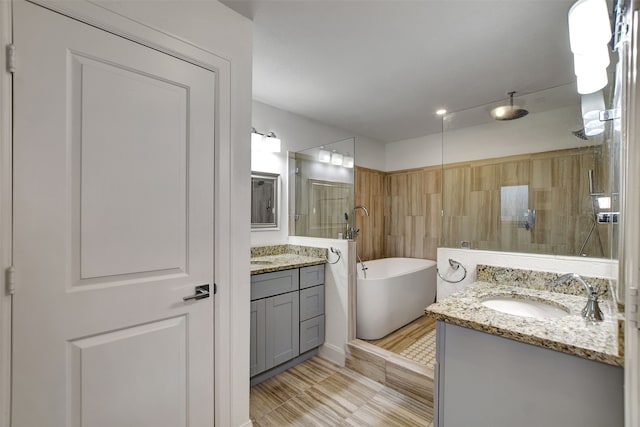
[{"xmin": 369, "ymin": 316, "xmax": 436, "ymax": 368}]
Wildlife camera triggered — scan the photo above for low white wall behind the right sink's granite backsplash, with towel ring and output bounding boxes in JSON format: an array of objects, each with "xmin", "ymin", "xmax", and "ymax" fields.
[{"xmin": 436, "ymin": 248, "xmax": 618, "ymax": 301}]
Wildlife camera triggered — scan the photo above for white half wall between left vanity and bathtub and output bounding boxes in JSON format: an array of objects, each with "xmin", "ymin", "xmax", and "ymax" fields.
[{"xmin": 289, "ymin": 236, "xmax": 355, "ymax": 366}]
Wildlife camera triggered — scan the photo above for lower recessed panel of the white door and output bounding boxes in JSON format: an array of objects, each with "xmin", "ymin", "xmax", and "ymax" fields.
[{"xmin": 68, "ymin": 316, "xmax": 187, "ymax": 427}]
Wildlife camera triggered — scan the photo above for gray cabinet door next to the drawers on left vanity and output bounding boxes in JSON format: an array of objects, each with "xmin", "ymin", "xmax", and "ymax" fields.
[{"xmin": 264, "ymin": 292, "xmax": 300, "ymax": 369}]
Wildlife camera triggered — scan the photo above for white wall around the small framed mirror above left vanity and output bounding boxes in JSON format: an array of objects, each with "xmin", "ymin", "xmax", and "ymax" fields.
[{"xmin": 246, "ymin": 100, "xmax": 385, "ymax": 246}]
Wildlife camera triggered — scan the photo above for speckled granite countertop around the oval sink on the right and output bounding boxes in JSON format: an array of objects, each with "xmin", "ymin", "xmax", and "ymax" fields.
[{"xmin": 425, "ymin": 282, "xmax": 624, "ymax": 366}]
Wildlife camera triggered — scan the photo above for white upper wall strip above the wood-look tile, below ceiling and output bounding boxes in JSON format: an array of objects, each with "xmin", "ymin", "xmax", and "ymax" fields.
[{"xmin": 385, "ymin": 107, "xmax": 601, "ymax": 171}]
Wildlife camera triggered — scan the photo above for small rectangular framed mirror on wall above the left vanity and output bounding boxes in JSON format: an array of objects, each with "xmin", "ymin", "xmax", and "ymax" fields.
[{"xmin": 251, "ymin": 172, "xmax": 280, "ymax": 230}]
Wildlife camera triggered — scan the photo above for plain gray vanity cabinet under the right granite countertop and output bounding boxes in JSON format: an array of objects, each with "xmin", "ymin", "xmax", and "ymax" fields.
[{"xmin": 434, "ymin": 320, "xmax": 624, "ymax": 427}]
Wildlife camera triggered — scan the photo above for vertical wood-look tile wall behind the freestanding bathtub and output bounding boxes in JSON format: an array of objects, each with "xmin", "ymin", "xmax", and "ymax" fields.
[{"xmin": 356, "ymin": 147, "xmax": 610, "ymax": 260}]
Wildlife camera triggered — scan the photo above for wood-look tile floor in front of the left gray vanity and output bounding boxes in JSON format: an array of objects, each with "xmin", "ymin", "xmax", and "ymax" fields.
[{"xmin": 250, "ymin": 357, "xmax": 433, "ymax": 427}]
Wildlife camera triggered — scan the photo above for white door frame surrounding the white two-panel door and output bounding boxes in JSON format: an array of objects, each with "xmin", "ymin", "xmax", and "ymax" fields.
[{"xmin": 0, "ymin": 0, "xmax": 251, "ymax": 426}]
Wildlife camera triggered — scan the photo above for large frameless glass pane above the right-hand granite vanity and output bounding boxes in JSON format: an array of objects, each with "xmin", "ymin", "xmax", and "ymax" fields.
[{"xmin": 442, "ymin": 84, "xmax": 612, "ymax": 258}]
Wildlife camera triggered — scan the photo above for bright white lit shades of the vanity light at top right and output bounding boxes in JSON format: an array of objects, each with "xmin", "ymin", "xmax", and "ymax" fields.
[{"xmin": 569, "ymin": 0, "xmax": 611, "ymax": 95}]
